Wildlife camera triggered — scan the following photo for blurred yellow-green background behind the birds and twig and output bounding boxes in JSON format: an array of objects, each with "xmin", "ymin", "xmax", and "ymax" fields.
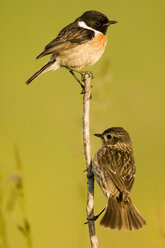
[{"xmin": 0, "ymin": 0, "xmax": 165, "ymax": 248}]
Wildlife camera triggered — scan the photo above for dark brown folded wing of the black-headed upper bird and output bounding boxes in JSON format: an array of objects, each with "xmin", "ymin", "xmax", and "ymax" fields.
[{"xmin": 37, "ymin": 23, "xmax": 95, "ymax": 59}]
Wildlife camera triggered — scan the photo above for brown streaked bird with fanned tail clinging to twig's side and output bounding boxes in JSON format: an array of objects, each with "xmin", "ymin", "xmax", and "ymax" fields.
[{"xmin": 92, "ymin": 127, "xmax": 146, "ymax": 231}]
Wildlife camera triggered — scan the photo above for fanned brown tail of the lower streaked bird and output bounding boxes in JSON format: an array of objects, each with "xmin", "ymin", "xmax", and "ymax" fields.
[{"xmin": 100, "ymin": 198, "xmax": 146, "ymax": 231}]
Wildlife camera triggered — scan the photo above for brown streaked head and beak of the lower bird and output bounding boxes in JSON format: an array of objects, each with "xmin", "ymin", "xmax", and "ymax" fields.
[{"xmin": 94, "ymin": 127, "xmax": 132, "ymax": 146}]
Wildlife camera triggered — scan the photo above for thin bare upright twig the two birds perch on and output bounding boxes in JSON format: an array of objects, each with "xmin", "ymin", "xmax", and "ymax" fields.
[{"xmin": 83, "ymin": 73, "xmax": 99, "ymax": 248}]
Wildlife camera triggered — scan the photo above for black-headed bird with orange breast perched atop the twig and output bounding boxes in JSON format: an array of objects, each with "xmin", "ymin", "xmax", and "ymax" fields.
[{"xmin": 26, "ymin": 10, "xmax": 117, "ymax": 84}]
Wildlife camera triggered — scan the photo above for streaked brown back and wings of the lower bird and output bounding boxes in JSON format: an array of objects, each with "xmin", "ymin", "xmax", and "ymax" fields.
[{"xmin": 97, "ymin": 147, "xmax": 136, "ymax": 193}]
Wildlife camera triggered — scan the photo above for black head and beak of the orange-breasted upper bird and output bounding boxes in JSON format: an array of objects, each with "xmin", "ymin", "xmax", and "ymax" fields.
[{"xmin": 76, "ymin": 10, "xmax": 117, "ymax": 34}]
